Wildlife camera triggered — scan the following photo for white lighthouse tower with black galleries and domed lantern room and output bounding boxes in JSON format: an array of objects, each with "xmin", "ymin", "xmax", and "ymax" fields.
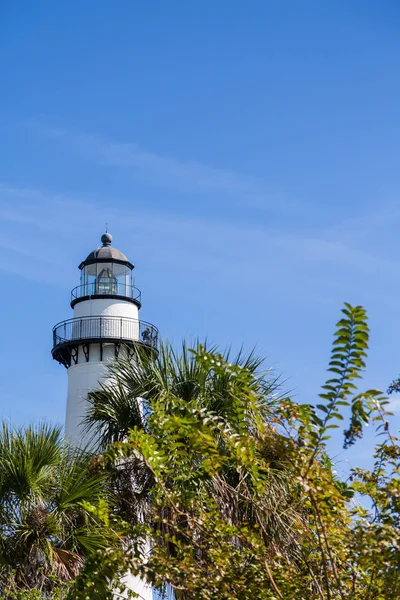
[{"xmin": 52, "ymin": 233, "xmax": 158, "ymax": 446}]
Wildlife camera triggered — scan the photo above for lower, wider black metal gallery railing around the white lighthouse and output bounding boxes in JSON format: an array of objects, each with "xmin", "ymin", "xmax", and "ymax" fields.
[{"xmin": 53, "ymin": 316, "xmax": 158, "ymax": 350}]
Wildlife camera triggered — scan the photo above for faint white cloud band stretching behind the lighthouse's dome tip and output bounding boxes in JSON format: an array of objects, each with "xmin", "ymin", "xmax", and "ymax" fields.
[{"xmin": 0, "ymin": 180, "xmax": 398, "ymax": 297}]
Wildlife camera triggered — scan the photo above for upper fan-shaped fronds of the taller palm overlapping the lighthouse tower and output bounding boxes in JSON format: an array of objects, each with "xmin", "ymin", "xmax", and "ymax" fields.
[{"xmin": 85, "ymin": 342, "xmax": 278, "ymax": 449}]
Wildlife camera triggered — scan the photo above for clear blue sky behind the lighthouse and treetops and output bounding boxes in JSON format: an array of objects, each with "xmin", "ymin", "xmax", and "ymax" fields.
[{"xmin": 0, "ymin": 0, "xmax": 400, "ymax": 476}]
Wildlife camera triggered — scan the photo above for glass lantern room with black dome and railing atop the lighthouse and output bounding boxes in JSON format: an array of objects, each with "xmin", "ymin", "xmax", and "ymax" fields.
[{"xmin": 71, "ymin": 232, "xmax": 141, "ymax": 308}]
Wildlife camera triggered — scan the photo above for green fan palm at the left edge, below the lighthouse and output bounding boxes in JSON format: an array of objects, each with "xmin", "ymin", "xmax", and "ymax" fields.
[{"xmin": 0, "ymin": 424, "xmax": 107, "ymax": 597}]
